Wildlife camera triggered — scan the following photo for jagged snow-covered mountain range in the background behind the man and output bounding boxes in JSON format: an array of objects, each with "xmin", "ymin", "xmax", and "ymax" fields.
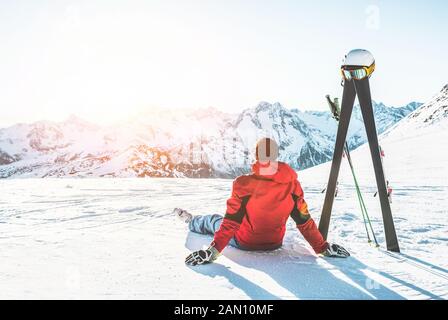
[{"xmin": 0, "ymin": 102, "xmax": 419, "ymax": 178}]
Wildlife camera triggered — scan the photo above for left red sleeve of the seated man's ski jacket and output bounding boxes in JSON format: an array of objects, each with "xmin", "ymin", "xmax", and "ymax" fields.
[{"xmin": 211, "ymin": 179, "xmax": 249, "ymax": 252}]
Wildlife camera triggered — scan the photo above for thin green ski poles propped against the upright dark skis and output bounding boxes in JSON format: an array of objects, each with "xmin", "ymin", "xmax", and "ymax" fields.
[{"xmin": 325, "ymin": 95, "xmax": 384, "ymax": 247}]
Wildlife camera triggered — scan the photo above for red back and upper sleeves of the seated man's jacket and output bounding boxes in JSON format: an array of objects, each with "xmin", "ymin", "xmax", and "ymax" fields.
[{"xmin": 227, "ymin": 162, "xmax": 306, "ymax": 250}]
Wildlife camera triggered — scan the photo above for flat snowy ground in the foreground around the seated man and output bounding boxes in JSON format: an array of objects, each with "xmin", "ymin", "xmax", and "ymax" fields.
[{"xmin": 0, "ymin": 179, "xmax": 448, "ymax": 299}]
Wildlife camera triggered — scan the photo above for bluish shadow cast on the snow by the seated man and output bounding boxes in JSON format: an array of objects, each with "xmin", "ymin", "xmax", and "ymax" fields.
[{"xmin": 185, "ymin": 232, "xmax": 406, "ymax": 299}]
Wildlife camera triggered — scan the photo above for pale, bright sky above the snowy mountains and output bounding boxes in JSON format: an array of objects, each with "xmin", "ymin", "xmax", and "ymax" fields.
[{"xmin": 0, "ymin": 0, "xmax": 448, "ymax": 126}]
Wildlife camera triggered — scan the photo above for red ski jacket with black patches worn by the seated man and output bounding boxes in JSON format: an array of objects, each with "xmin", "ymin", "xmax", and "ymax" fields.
[{"xmin": 212, "ymin": 162, "xmax": 328, "ymax": 253}]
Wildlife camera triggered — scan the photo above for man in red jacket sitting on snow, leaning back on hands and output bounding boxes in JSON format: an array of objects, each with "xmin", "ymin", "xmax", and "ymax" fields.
[{"xmin": 174, "ymin": 138, "xmax": 350, "ymax": 266}]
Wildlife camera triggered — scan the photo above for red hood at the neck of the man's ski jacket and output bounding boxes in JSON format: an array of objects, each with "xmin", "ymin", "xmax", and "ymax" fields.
[{"xmin": 252, "ymin": 161, "xmax": 297, "ymax": 183}]
